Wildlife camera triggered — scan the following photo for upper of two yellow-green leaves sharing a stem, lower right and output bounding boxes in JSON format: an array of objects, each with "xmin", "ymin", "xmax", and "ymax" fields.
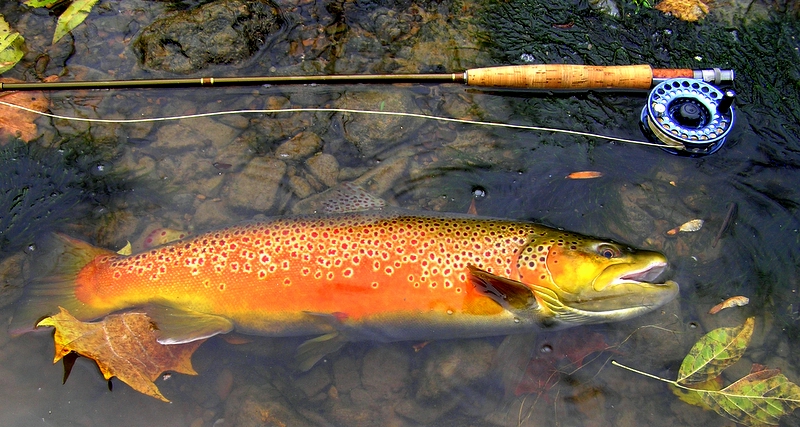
[{"xmin": 677, "ymin": 317, "xmax": 755, "ymax": 385}]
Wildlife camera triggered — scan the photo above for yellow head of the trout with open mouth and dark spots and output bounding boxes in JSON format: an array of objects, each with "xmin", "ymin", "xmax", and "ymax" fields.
[{"xmin": 516, "ymin": 230, "xmax": 679, "ymax": 326}]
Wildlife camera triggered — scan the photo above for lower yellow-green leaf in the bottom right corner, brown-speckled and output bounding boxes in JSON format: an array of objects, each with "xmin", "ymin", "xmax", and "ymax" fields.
[{"xmin": 697, "ymin": 369, "xmax": 800, "ymax": 426}]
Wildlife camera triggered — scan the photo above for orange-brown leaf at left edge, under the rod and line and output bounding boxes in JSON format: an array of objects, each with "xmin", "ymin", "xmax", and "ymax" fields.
[{"xmin": 0, "ymin": 76, "xmax": 58, "ymax": 144}]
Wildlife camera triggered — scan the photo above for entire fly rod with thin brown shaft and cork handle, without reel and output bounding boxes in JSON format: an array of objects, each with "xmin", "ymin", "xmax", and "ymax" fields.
[{"xmin": 0, "ymin": 64, "xmax": 734, "ymax": 91}]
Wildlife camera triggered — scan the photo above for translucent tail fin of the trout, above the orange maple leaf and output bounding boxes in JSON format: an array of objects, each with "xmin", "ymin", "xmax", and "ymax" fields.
[{"xmin": 9, "ymin": 234, "xmax": 116, "ymax": 335}]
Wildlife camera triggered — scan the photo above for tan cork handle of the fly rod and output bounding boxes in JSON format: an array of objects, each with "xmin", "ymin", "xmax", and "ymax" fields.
[{"xmin": 465, "ymin": 64, "xmax": 653, "ymax": 90}]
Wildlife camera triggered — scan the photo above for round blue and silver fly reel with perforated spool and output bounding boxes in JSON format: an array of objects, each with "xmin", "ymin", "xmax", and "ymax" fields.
[{"xmin": 639, "ymin": 78, "xmax": 736, "ymax": 157}]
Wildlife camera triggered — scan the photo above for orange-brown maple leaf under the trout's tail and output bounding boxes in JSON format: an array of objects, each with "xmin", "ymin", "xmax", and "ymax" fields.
[{"xmin": 36, "ymin": 307, "xmax": 205, "ymax": 402}]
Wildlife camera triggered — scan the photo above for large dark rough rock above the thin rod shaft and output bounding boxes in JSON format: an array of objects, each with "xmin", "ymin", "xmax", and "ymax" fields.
[{"xmin": 134, "ymin": 0, "xmax": 282, "ymax": 73}]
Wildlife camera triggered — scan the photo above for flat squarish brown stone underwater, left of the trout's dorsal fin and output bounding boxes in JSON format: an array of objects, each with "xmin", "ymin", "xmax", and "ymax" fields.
[{"xmin": 225, "ymin": 157, "xmax": 286, "ymax": 212}]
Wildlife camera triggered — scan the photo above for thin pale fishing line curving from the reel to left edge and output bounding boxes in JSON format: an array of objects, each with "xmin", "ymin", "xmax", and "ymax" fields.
[{"xmin": 0, "ymin": 101, "xmax": 664, "ymax": 148}]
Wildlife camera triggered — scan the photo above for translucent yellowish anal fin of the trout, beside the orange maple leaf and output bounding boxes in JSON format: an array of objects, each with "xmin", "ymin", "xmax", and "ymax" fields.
[{"xmin": 144, "ymin": 304, "xmax": 233, "ymax": 344}]
